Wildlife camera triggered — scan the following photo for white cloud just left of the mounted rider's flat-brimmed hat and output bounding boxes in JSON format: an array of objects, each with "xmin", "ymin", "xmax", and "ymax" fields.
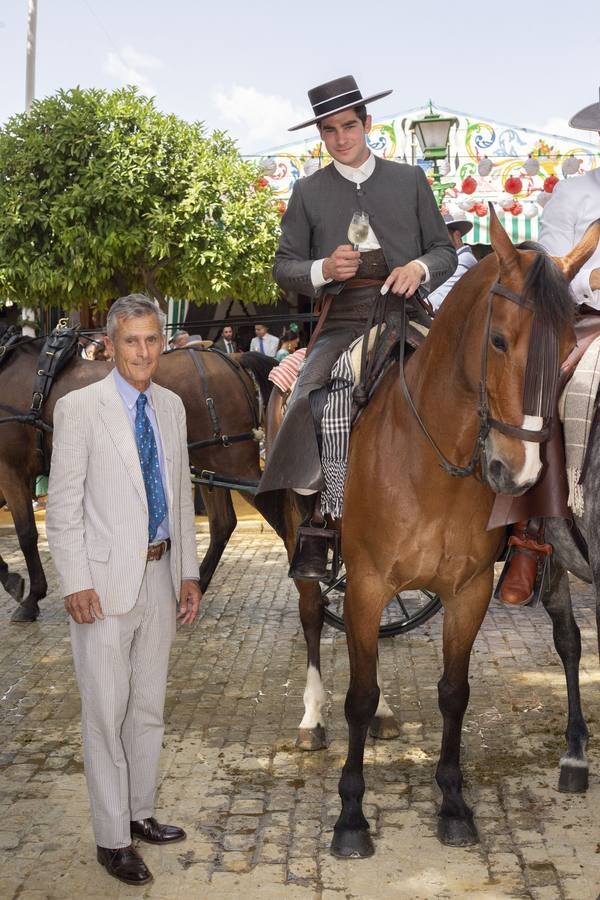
[{"xmin": 213, "ymin": 84, "xmax": 310, "ymax": 150}]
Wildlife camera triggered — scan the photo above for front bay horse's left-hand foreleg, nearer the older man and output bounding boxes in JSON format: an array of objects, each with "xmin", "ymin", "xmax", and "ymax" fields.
[{"xmin": 331, "ymin": 576, "xmax": 383, "ymax": 858}]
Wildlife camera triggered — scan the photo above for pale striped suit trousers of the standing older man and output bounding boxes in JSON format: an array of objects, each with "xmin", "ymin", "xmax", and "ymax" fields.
[{"xmin": 70, "ymin": 553, "xmax": 176, "ymax": 847}]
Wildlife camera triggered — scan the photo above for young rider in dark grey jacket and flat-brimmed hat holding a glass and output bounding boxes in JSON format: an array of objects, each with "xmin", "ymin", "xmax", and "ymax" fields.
[{"xmin": 256, "ymin": 75, "xmax": 457, "ymax": 579}]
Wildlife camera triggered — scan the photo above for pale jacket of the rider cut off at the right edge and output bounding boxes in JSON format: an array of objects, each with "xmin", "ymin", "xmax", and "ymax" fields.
[{"xmin": 540, "ymin": 169, "xmax": 600, "ymax": 309}]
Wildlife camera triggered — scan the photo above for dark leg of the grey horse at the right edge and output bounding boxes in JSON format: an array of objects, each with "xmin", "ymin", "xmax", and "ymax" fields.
[{"xmin": 543, "ymin": 563, "xmax": 588, "ymax": 794}]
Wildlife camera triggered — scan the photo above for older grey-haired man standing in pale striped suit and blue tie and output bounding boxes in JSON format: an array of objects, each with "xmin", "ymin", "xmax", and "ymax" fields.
[{"xmin": 46, "ymin": 294, "xmax": 201, "ymax": 885}]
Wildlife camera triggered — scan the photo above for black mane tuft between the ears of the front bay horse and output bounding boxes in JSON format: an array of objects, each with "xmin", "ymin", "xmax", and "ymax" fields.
[{"xmin": 517, "ymin": 241, "xmax": 575, "ymax": 333}]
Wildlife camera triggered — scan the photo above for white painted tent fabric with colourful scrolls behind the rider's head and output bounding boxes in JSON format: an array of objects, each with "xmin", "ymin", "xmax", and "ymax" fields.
[{"xmin": 255, "ymin": 106, "xmax": 600, "ymax": 244}]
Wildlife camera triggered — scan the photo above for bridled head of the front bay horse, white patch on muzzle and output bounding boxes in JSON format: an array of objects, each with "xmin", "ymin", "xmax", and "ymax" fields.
[{"xmin": 472, "ymin": 206, "xmax": 600, "ymax": 494}]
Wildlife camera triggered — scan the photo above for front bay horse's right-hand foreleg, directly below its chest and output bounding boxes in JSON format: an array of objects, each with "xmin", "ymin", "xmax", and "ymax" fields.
[{"xmin": 435, "ymin": 574, "xmax": 492, "ymax": 847}]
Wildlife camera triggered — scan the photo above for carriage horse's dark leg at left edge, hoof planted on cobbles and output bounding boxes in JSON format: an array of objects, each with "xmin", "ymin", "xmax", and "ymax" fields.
[{"xmin": 2, "ymin": 472, "xmax": 48, "ymax": 622}]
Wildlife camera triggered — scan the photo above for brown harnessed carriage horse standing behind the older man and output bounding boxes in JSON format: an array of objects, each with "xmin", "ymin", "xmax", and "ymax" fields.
[{"xmin": 0, "ymin": 339, "xmax": 262, "ymax": 622}]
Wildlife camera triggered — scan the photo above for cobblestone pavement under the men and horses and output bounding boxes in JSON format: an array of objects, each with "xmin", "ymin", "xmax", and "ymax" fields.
[{"xmin": 0, "ymin": 529, "xmax": 600, "ymax": 900}]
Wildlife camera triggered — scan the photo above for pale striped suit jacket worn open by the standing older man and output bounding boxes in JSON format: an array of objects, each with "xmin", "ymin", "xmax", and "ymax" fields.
[{"xmin": 46, "ymin": 372, "xmax": 198, "ymax": 615}]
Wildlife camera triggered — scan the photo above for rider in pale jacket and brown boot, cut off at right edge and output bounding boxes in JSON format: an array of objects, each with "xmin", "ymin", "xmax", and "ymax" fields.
[{"xmin": 494, "ymin": 89, "xmax": 600, "ymax": 606}]
